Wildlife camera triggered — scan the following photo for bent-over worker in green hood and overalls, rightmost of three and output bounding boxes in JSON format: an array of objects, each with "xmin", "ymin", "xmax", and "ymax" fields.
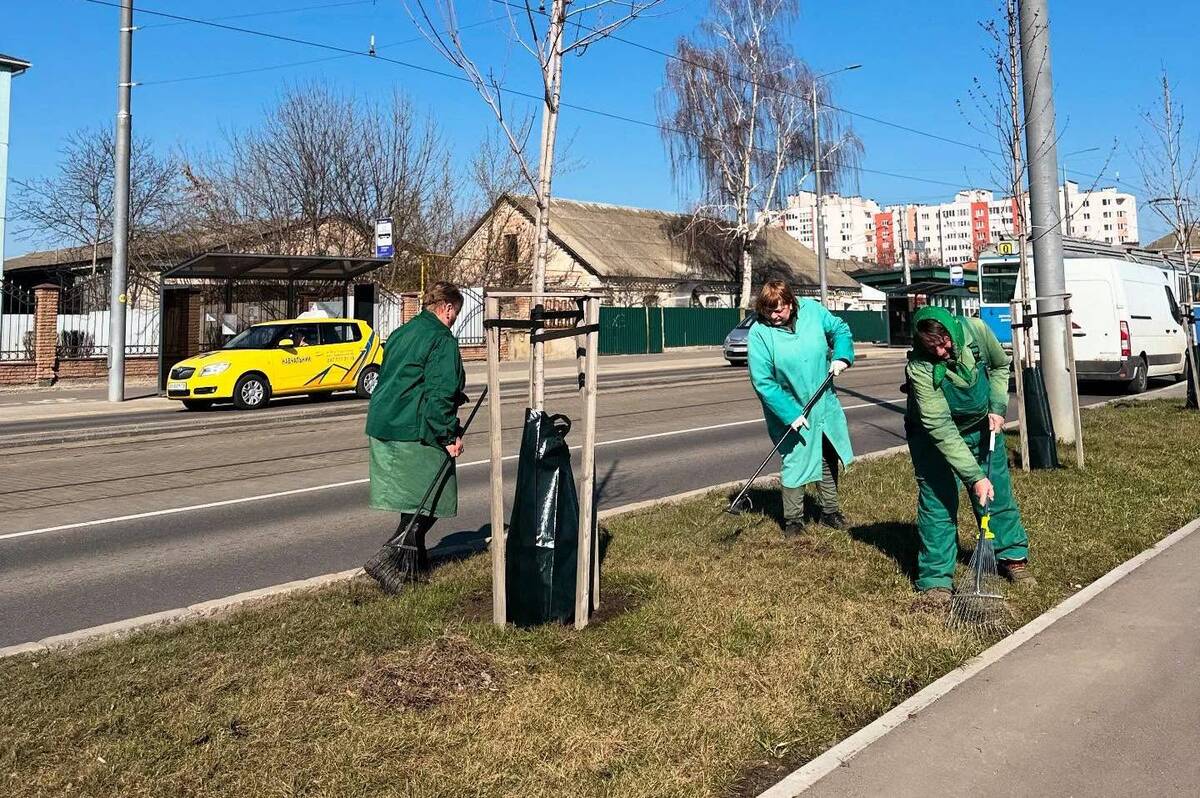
[{"xmin": 905, "ymin": 307, "xmax": 1034, "ymax": 604}]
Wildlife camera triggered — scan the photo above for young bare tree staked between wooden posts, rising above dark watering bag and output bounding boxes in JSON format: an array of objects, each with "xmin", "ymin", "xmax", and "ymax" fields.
[{"xmin": 406, "ymin": 0, "xmax": 662, "ymax": 409}]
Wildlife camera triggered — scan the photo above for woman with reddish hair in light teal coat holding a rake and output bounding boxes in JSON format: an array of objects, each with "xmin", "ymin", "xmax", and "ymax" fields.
[{"xmin": 748, "ymin": 280, "xmax": 854, "ymax": 536}]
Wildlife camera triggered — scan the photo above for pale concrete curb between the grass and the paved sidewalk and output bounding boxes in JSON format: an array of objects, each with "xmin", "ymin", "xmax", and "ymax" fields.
[{"xmin": 758, "ymin": 518, "xmax": 1200, "ymax": 798}]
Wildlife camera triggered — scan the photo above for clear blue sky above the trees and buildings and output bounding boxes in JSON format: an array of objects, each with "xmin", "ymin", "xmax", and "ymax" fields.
[{"xmin": 0, "ymin": 0, "xmax": 1200, "ymax": 257}]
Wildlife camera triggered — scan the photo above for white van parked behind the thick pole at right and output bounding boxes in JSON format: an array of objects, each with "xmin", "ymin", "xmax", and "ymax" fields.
[{"xmin": 1064, "ymin": 254, "xmax": 1187, "ymax": 394}]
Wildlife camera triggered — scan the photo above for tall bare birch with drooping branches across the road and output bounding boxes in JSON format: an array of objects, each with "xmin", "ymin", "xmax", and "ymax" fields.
[{"xmin": 659, "ymin": 0, "xmax": 863, "ymax": 308}]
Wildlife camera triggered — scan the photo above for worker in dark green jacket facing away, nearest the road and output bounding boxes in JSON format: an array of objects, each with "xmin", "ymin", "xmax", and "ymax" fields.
[{"xmin": 364, "ymin": 282, "xmax": 467, "ymax": 589}]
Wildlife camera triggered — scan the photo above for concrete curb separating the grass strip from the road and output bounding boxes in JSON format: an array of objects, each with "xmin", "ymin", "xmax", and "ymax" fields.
[{"xmin": 0, "ymin": 444, "xmax": 907, "ymax": 659}]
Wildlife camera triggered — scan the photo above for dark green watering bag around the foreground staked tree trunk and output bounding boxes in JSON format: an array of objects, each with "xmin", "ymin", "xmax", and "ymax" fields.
[{"xmin": 505, "ymin": 409, "xmax": 580, "ymax": 626}]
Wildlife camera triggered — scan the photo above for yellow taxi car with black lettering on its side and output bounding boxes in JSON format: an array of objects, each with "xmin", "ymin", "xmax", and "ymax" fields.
[{"xmin": 167, "ymin": 318, "xmax": 383, "ymax": 410}]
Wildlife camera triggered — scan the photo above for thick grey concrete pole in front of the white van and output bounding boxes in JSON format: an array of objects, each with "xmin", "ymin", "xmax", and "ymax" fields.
[{"xmin": 1020, "ymin": 0, "xmax": 1076, "ymax": 443}]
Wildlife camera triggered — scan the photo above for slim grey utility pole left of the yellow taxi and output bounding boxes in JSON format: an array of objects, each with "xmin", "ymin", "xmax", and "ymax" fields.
[{"xmin": 108, "ymin": 0, "xmax": 133, "ymax": 402}]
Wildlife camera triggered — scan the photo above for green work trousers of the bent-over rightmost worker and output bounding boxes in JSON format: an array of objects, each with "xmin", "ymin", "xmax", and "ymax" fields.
[{"xmin": 908, "ymin": 426, "xmax": 1028, "ymax": 590}]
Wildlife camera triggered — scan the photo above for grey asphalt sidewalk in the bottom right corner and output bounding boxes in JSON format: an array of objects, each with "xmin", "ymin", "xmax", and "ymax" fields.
[{"xmin": 802, "ymin": 520, "xmax": 1200, "ymax": 798}]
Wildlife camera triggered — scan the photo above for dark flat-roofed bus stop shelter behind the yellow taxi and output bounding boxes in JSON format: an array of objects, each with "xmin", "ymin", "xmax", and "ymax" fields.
[{"xmin": 158, "ymin": 252, "xmax": 392, "ymax": 389}]
